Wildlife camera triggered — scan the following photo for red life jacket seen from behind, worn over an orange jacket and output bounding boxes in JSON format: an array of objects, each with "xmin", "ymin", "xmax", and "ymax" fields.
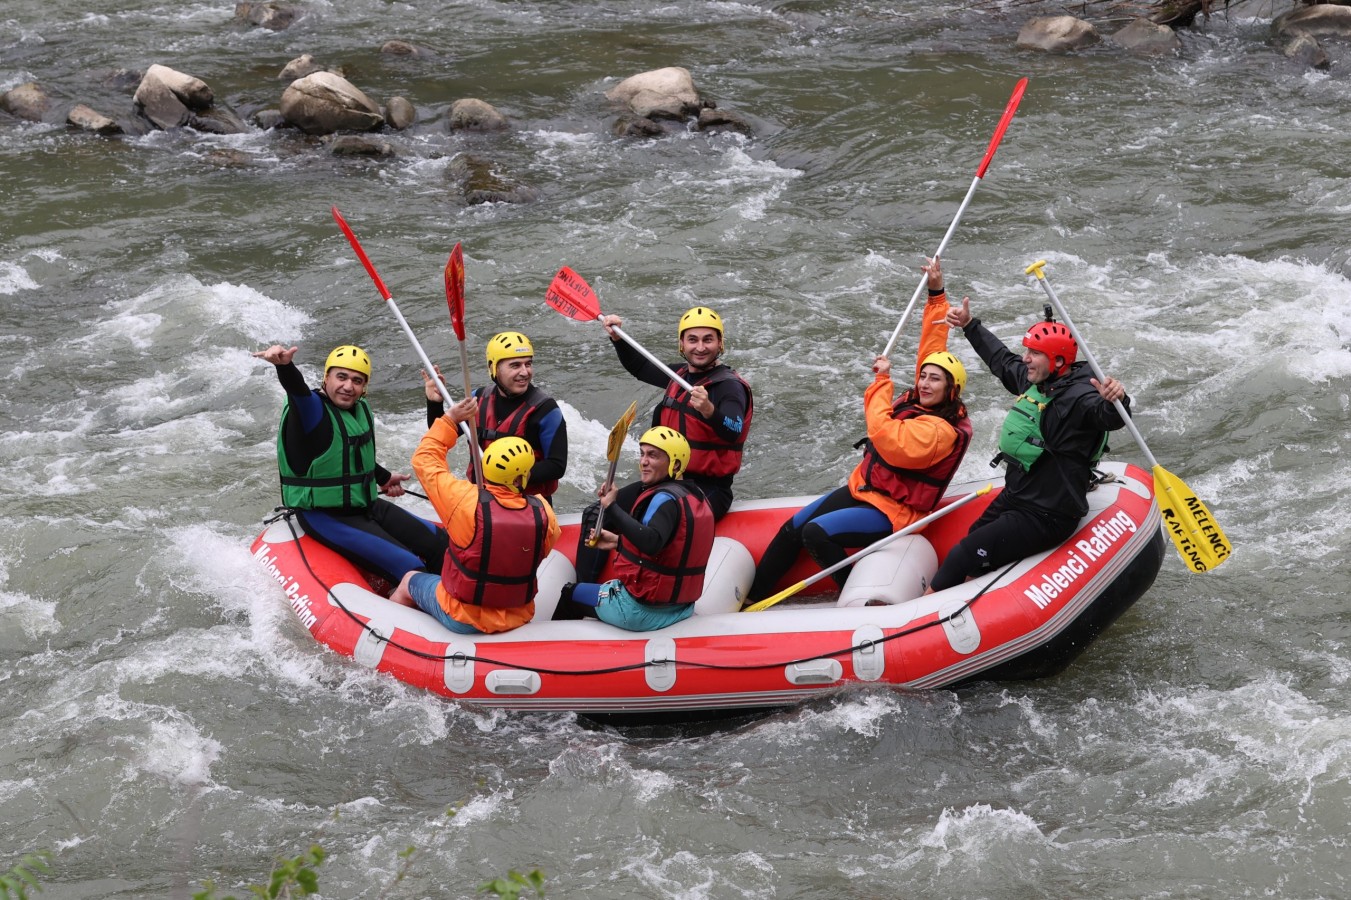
[{"xmin": 440, "ymin": 488, "xmax": 549, "ymax": 609}]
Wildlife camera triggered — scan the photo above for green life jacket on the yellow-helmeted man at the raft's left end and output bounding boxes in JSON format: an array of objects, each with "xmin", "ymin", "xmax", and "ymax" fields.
[{"xmin": 277, "ymin": 399, "xmax": 378, "ymax": 509}]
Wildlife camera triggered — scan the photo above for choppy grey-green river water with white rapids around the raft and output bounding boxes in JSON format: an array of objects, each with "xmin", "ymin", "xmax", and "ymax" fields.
[{"xmin": 0, "ymin": 0, "xmax": 1351, "ymax": 899}]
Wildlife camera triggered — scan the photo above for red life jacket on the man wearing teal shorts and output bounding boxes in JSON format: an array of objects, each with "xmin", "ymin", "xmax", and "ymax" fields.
[{"xmin": 615, "ymin": 481, "xmax": 713, "ymax": 603}]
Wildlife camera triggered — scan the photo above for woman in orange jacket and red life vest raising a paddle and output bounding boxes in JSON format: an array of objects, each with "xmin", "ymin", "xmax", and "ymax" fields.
[{"xmin": 747, "ymin": 257, "xmax": 971, "ymax": 603}]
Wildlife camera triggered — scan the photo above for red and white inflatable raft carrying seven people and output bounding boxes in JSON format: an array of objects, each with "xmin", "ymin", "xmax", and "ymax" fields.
[{"xmin": 253, "ymin": 464, "xmax": 1163, "ymax": 720}]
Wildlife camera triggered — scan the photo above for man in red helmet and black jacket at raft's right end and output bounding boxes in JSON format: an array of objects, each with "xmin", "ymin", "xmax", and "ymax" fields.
[{"xmin": 929, "ymin": 299, "xmax": 1131, "ymax": 592}]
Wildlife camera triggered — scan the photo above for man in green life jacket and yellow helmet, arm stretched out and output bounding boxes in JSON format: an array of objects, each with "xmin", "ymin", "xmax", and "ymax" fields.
[{"xmin": 253, "ymin": 345, "xmax": 447, "ymax": 585}]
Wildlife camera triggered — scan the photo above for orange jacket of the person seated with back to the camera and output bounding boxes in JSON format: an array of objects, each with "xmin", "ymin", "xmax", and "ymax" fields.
[{"xmin": 413, "ymin": 416, "xmax": 562, "ymax": 634}]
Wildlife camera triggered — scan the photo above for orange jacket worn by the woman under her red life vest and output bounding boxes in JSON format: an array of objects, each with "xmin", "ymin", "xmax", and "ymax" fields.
[{"xmin": 848, "ymin": 293, "xmax": 958, "ymax": 531}]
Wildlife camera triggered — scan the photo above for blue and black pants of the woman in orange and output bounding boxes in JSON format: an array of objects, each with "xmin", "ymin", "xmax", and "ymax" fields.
[{"xmin": 747, "ymin": 485, "xmax": 892, "ymax": 600}]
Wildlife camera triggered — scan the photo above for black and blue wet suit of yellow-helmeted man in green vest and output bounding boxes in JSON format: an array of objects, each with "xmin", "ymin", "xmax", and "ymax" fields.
[{"xmin": 277, "ymin": 364, "xmax": 449, "ymax": 584}]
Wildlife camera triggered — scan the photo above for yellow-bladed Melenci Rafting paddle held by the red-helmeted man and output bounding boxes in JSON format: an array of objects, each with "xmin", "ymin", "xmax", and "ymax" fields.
[{"xmin": 1024, "ymin": 259, "xmax": 1233, "ymax": 572}]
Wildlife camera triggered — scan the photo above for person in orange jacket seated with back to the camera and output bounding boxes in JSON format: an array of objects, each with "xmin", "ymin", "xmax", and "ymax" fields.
[{"xmin": 389, "ymin": 397, "xmax": 562, "ymax": 634}]
